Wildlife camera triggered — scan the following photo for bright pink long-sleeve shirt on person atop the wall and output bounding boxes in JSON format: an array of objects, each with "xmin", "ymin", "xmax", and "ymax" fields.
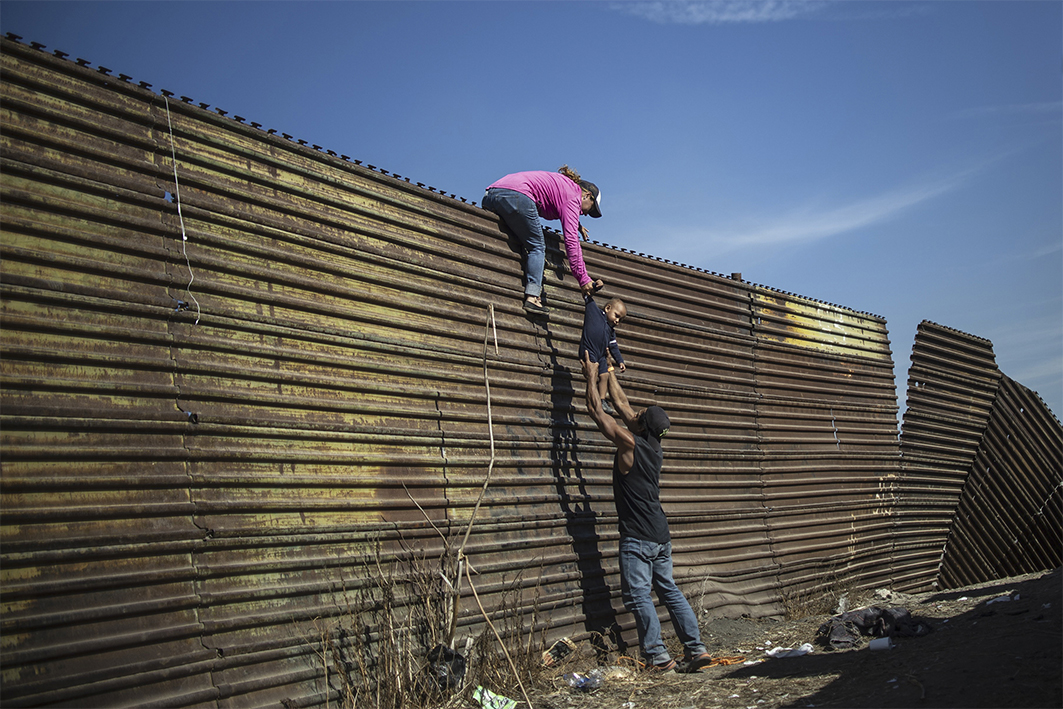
[{"xmin": 488, "ymin": 170, "xmax": 591, "ymax": 286}]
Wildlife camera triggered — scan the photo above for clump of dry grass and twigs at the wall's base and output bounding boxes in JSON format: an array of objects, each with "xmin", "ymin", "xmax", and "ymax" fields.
[{"xmin": 295, "ymin": 539, "xmax": 546, "ymax": 709}]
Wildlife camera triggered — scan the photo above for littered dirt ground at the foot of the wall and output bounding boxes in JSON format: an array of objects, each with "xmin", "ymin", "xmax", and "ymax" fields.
[{"xmin": 497, "ymin": 569, "xmax": 1063, "ymax": 709}]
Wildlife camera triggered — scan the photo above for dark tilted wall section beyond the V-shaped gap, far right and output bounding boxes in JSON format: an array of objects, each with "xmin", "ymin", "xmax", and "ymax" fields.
[{"xmin": 896, "ymin": 321, "xmax": 1063, "ymax": 589}]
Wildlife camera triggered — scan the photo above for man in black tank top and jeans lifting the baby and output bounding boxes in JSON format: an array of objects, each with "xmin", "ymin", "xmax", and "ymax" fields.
[{"xmin": 583, "ymin": 354, "xmax": 711, "ymax": 672}]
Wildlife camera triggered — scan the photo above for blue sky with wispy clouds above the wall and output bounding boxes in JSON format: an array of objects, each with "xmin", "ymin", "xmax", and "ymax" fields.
[{"xmin": 0, "ymin": 0, "xmax": 1063, "ymax": 417}]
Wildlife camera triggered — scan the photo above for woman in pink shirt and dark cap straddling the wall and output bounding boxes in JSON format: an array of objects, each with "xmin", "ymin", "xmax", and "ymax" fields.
[{"xmin": 484, "ymin": 165, "xmax": 605, "ymax": 315}]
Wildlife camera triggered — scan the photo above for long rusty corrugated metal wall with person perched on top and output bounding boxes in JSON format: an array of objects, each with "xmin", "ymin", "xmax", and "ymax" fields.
[{"xmin": 0, "ymin": 37, "xmax": 1054, "ymax": 707}]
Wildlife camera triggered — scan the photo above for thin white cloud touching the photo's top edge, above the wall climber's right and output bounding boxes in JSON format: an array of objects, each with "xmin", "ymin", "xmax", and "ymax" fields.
[{"xmin": 610, "ymin": 0, "xmax": 827, "ymax": 24}]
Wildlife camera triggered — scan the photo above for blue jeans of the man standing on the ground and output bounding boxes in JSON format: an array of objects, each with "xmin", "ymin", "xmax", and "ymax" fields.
[{"xmin": 620, "ymin": 537, "xmax": 705, "ymax": 664}]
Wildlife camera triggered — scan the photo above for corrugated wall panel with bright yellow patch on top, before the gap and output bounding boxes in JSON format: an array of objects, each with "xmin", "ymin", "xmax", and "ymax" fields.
[{"xmin": 754, "ymin": 293, "xmax": 899, "ymax": 595}]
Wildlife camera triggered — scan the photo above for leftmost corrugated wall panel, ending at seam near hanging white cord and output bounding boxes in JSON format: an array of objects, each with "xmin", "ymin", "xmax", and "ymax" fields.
[{"xmin": 0, "ymin": 52, "xmax": 216, "ymax": 706}]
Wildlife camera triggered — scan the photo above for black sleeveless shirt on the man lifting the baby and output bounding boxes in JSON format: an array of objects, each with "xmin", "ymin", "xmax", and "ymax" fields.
[{"xmin": 612, "ymin": 435, "xmax": 672, "ymax": 544}]
